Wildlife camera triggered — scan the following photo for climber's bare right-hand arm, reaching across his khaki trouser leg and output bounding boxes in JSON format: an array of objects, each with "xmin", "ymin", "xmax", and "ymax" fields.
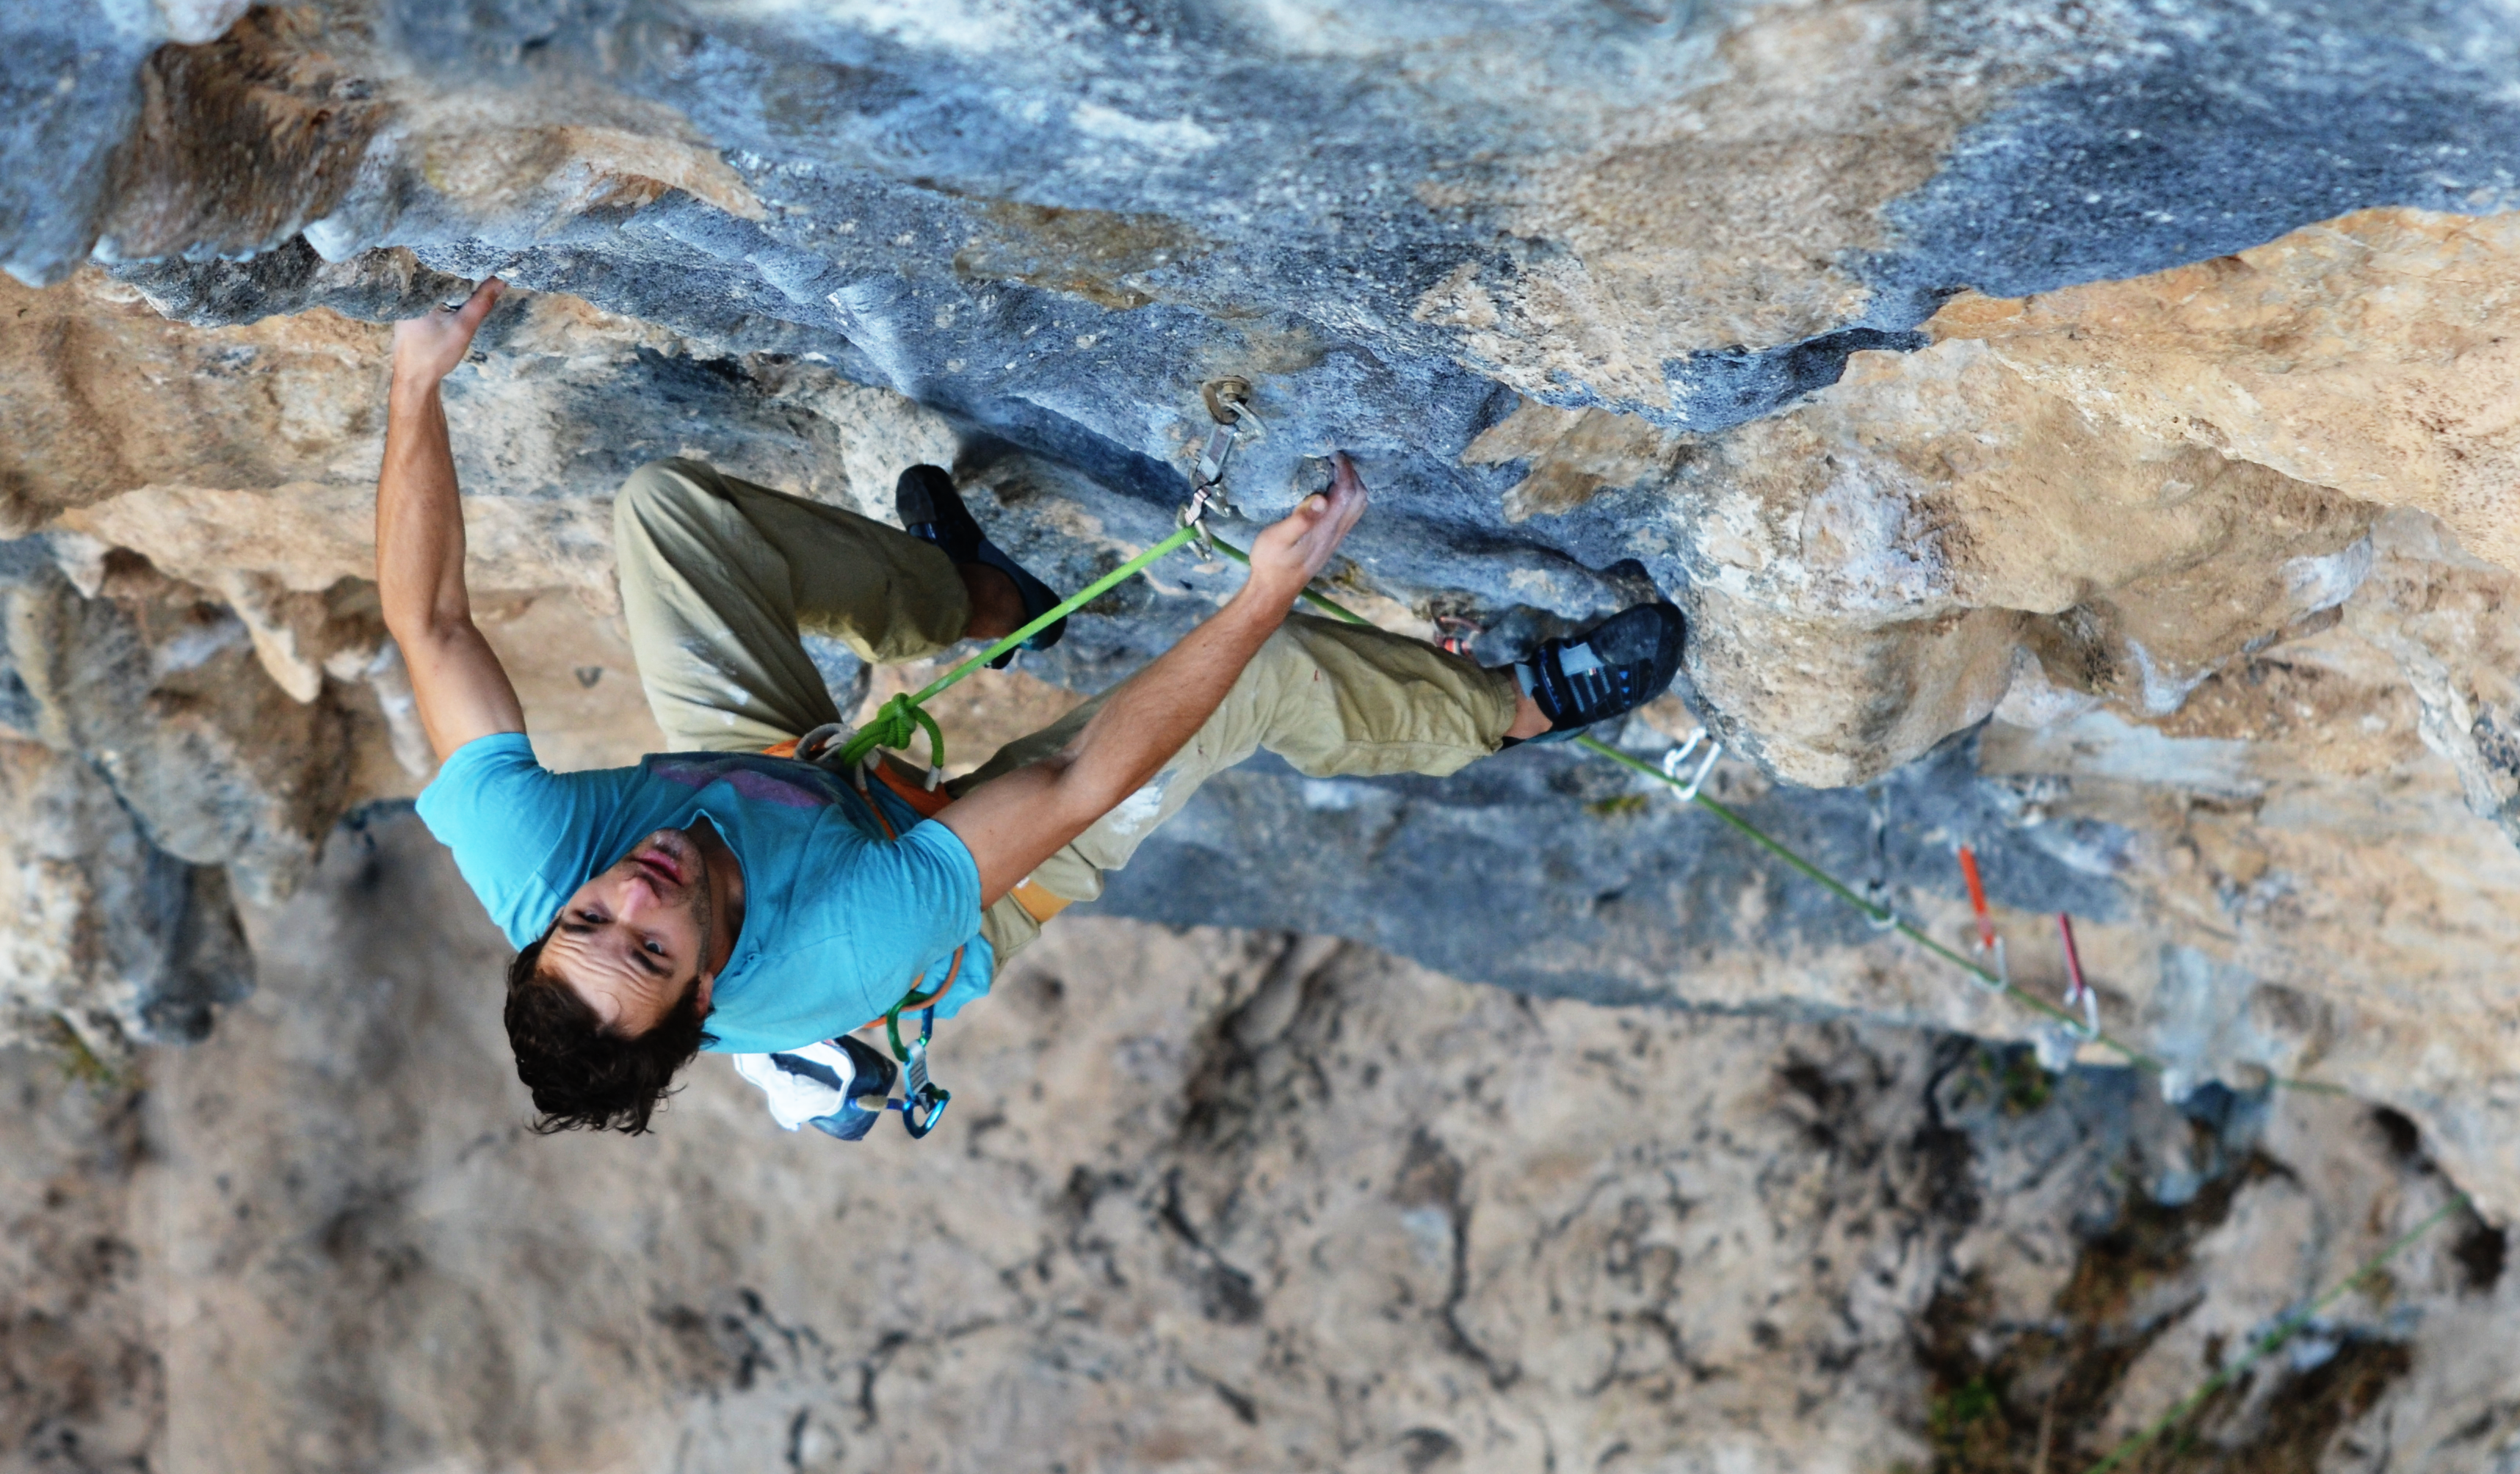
[{"xmin": 938, "ymin": 456, "xmax": 1366, "ymax": 904}]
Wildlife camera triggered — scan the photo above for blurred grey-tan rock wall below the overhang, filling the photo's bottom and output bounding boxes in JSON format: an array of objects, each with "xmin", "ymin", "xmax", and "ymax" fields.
[{"xmin": 0, "ymin": 816, "xmax": 2520, "ymax": 1474}]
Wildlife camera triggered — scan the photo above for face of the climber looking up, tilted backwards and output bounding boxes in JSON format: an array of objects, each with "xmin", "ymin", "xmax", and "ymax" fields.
[{"xmin": 539, "ymin": 829, "xmax": 713, "ymax": 1038}]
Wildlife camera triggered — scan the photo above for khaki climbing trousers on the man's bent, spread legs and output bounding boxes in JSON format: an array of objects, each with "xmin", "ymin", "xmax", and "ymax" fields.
[{"xmin": 612, "ymin": 461, "xmax": 1517, "ymax": 957}]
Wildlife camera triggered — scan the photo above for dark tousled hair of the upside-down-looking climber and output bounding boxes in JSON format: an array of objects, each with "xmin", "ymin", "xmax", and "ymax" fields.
[{"xmin": 507, "ymin": 932, "xmax": 716, "ymax": 1136}]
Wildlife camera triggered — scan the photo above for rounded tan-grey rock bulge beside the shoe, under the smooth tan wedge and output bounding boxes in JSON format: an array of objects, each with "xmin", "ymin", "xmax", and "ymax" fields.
[{"xmin": 1681, "ymin": 343, "xmax": 2374, "ymax": 786}]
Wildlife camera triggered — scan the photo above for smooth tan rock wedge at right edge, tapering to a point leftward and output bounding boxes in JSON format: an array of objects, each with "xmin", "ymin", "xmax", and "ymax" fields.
[{"xmin": 1925, "ymin": 209, "xmax": 2520, "ymax": 570}]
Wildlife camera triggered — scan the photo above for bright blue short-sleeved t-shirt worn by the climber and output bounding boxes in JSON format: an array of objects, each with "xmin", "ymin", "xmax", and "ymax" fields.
[{"xmin": 421, "ymin": 733, "xmax": 996, "ymax": 1053}]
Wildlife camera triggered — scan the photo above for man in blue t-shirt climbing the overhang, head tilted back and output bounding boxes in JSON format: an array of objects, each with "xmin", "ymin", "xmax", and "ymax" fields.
[{"xmin": 375, "ymin": 280, "xmax": 1681, "ymax": 1134}]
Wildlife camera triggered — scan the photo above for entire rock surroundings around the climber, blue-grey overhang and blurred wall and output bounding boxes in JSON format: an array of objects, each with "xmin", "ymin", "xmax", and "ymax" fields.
[{"xmin": 0, "ymin": 0, "xmax": 2520, "ymax": 1474}]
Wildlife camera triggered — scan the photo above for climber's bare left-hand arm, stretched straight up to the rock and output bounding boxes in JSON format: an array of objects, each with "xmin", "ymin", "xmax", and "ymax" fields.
[{"xmin": 375, "ymin": 277, "xmax": 524, "ymax": 761}]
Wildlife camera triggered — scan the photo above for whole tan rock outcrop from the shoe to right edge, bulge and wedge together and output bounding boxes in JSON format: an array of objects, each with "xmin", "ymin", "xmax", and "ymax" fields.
[{"xmin": 1676, "ymin": 209, "xmax": 2520, "ymax": 784}]
